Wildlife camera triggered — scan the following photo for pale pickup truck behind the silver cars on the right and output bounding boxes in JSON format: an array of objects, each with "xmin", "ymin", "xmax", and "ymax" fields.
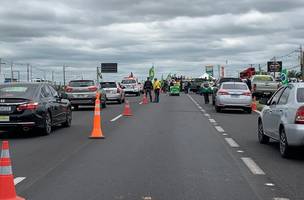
[{"xmin": 251, "ymin": 75, "xmax": 281, "ymax": 97}]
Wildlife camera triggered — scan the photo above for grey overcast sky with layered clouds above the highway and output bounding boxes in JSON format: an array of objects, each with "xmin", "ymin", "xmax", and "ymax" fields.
[{"xmin": 0, "ymin": 0, "xmax": 304, "ymax": 81}]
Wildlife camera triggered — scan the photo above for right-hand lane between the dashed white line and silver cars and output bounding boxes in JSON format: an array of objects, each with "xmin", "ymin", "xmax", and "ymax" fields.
[{"xmin": 191, "ymin": 95, "xmax": 304, "ymax": 200}]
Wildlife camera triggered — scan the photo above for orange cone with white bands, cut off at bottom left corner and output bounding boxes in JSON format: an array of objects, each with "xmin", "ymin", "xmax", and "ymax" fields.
[{"xmin": 0, "ymin": 141, "xmax": 25, "ymax": 200}]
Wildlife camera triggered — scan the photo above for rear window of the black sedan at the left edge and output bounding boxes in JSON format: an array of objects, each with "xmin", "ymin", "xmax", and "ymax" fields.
[{"xmin": 0, "ymin": 84, "xmax": 37, "ymax": 99}]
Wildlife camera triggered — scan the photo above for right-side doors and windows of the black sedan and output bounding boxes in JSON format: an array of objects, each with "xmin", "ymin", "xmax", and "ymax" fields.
[{"xmin": 48, "ymin": 85, "xmax": 67, "ymax": 123}]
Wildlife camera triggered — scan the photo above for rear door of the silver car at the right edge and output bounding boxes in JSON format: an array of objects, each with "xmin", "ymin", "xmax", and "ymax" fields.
[{"xmin": 271, "ymin": 87, "xmax": 291, "ymax": 139}]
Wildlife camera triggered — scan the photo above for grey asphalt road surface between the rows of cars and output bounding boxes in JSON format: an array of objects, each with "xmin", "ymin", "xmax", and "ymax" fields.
[{"xmin": 0, "ymin": 94, "xmax": 304, "ymax": 200}]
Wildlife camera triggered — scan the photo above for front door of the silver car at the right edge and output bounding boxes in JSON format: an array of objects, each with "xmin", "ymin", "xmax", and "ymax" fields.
[{"xmin": 263, "ymin": 87, "xmax": 285, "ymax": 137}]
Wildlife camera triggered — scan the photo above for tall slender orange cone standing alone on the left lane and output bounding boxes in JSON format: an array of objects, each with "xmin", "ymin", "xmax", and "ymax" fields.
[{"xmin": 90, "ymin": 93, "xmax": 105, "ymax": 139}]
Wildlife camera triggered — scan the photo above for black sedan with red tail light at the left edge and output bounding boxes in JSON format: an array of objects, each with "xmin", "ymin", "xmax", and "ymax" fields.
[{"xmin": 0, "ymin": 83, "xmax": 72, "ymax": 135}]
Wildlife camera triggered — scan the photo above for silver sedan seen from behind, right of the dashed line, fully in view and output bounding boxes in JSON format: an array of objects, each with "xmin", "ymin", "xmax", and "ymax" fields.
[{"xmin": 215, "ymin": 82, "xmax": 252, "ymax": 113}]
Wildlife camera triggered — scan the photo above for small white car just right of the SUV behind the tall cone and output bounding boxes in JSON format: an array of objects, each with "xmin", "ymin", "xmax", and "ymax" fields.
[{"xmin": 100, "ymin": 82, "xmax": 125, "ymax": 104}]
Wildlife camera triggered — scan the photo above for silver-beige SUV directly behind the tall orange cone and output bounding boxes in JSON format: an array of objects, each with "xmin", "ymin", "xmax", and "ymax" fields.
[{"xmin": 65, "ymin": 80, "xmax": 106, "ymax": 109}]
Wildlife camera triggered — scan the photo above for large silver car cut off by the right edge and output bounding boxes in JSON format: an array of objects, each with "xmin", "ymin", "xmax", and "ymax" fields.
[{"xmin": 258, "ymin": 83, "xmax": 304, "ymax": 157}]
